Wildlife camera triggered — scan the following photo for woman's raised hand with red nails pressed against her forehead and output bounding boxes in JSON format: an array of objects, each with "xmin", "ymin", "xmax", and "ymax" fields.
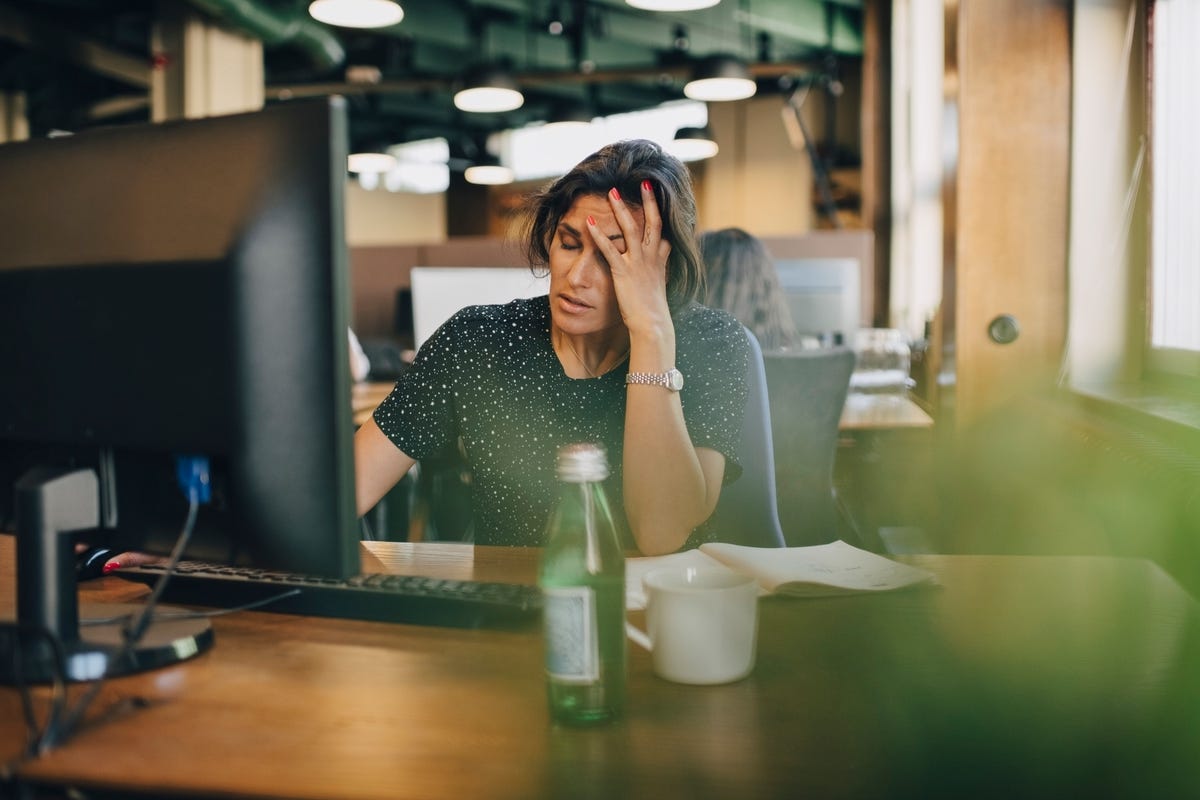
[{"xmin": 588, "ymin": 181, "xmax": 671, "ymax": 337}]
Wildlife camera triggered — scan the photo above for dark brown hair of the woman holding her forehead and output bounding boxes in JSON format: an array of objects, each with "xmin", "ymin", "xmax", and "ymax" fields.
[{"xmin": 522, "ymin": 139, "xmax": 704, "ymax": 309}]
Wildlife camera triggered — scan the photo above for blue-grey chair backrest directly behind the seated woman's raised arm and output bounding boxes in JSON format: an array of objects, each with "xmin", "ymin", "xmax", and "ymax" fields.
[{"xmin": 713, "ymin": 330, "xmax": 784, "ymax": 547}]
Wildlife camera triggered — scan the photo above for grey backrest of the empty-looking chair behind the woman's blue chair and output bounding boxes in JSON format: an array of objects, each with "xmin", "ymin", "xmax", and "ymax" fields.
[{"xmin": 763, "ymin": 347, "xmax": 854, "ymax": 546}]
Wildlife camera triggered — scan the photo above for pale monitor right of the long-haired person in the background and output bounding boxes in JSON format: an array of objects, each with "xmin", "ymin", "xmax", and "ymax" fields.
[{"xmin": 775, "ymin": 258, "xmax": 863, "ymax": 344}]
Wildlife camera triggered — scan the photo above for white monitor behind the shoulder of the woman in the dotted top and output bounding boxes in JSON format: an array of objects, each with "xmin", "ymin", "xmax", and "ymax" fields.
[{"xmin": 409, "ymin": 266, "xmax": 550, "ymax": 348}]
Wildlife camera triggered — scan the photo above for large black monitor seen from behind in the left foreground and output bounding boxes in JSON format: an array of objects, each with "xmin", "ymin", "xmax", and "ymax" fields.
[{"xmin": 0, "ymin": 98, "xmax": 360, "ymax": 678}]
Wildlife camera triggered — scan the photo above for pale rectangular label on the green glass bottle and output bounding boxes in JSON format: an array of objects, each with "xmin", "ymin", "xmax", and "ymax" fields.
[{"xmin": 542, "ymin": 587, "xmax": 600, "ymax": 684}]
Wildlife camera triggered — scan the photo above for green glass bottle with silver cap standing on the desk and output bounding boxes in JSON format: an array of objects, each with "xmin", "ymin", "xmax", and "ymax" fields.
[{"xmin": 539, "ymin": 444, "xmax": 625, "ymax": 724}]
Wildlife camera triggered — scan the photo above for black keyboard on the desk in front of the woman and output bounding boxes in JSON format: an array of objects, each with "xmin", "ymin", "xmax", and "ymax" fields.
[{"xmin": 110, "ymin": 561, "xmax": 541, "ymax": 628}]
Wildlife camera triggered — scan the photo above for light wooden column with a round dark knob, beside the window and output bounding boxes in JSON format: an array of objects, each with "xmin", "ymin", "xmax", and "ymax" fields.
[{"xmin": 954, "ymin": 0, "xmax": 1072, "ymax": 423}]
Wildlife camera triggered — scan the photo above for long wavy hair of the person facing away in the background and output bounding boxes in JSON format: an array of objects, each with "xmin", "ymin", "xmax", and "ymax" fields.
[{"xmin": 700, "ymin": 228, "xmax": 798, "ymax": 350}]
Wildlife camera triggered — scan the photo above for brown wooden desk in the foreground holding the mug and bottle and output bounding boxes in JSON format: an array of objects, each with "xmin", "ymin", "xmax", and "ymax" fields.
[{"xmin": 0, "ymin": 537, "xmax": 1200, "ymax": 800}]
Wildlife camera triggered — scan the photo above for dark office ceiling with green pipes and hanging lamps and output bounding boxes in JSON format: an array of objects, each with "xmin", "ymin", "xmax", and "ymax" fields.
[{"xmin": 0, "ymin": 0, "xmax": 863, "ymax": 154}]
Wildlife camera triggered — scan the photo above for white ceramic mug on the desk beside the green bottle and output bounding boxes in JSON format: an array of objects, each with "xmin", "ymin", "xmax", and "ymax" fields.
[{"xmin": 625, "ymin": 567, "xmax": 758, "ymax": 685}]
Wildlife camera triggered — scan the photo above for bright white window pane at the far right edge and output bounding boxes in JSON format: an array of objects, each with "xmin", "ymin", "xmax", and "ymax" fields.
[{"xmin": 1147, "ymin": 0, "xmax": 1200, "ymax": 375}]
